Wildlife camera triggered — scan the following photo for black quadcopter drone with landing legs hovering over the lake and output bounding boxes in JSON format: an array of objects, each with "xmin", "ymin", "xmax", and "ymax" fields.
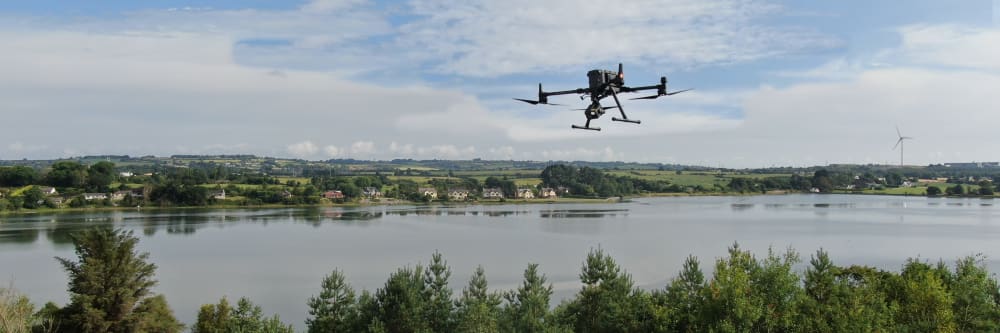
[{"xmin": 514, "ymin": 63, "xmax": 691, "ymax": 131}]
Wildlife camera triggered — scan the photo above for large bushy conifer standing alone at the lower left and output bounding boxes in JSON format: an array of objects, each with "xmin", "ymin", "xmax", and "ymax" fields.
[{"xmin": 56, "ymin": 228, "xmax": 165, "ymax": 333}]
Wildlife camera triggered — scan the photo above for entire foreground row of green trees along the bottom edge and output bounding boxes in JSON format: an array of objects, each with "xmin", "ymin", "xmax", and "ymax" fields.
[{"xmin": 0, "ymin": 229, "xmax": 1000, "ymax": 333}]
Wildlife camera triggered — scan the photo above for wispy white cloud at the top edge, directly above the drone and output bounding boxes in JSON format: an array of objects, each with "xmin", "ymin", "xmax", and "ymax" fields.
[{"xmin": 400, "ymin": 0, "xmax": 840, "ymax": 76}]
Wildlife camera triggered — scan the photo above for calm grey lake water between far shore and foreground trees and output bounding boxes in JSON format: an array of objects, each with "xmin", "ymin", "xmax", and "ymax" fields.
[{"xmin": 0, "ymin": 195, "xmax": 1000, "ymax": 330}]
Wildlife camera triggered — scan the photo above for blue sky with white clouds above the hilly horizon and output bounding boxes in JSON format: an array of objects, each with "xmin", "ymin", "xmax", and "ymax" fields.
[{"xmin": 0, "ymin": 0, "xmax": 1000, "ymax": 168}]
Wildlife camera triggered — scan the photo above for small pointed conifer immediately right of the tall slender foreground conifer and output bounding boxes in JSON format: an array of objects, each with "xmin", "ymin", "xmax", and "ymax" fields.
[{"xmin": 455, "ymin": 266, "xmax": 501, "ymax": 332}]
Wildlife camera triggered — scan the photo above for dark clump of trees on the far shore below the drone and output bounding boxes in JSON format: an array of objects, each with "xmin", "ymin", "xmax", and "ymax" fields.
[{"xmin": 541, "ymin": 164, "xmax": 687, "ymax": 197}]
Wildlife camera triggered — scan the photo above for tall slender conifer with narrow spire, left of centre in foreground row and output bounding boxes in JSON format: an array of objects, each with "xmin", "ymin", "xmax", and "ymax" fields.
[{"xmin": 423, "ymin": 251, "xmax": 454, "ymax": 332}]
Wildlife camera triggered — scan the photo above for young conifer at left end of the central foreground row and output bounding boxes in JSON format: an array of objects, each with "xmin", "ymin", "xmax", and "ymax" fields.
[{"xmin": 306, "ymin": 270, "xmax": 357, "ymax": 333}]
